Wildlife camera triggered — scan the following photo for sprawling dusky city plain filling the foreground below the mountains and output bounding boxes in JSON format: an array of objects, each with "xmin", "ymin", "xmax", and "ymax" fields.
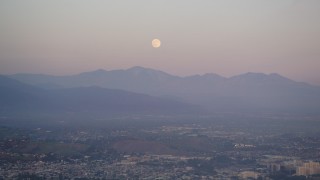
[{"xmin": 0, "ymin": 114, "xmax": 320, "ymax": 179}]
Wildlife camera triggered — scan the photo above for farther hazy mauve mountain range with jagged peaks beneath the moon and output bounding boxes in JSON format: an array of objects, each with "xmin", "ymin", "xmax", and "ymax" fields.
[{"xmin": 8, "ymin": 66, "xmax": 320, "ymax": 113}]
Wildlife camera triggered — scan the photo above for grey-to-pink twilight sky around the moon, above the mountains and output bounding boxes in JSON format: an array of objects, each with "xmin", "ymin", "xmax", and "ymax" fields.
[{"xmin": 0, "ymin": 0, "xmax": 320, "ymax": 85}]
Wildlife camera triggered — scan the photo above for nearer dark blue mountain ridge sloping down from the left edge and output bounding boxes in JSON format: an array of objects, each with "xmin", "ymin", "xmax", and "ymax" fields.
[{"xmin": 0, "ymin": 75, "xmax": 203, "ymax": 117}]
